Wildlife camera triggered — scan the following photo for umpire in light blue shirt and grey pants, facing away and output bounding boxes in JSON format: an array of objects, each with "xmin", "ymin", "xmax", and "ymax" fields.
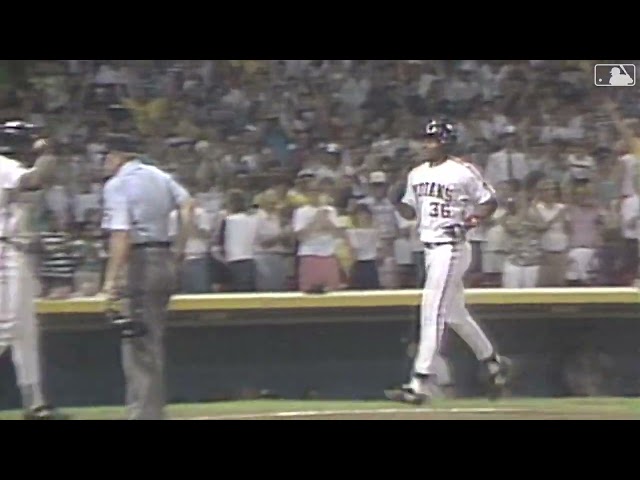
[{"xmin": 102, "ymin": 138, "xmax": 193, "ymax": 420}]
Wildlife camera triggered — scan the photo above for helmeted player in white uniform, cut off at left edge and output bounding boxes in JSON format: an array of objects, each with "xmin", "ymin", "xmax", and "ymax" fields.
[{"xmin": 0, "ymin": 122, "xmax": 63, "ymax": 420}]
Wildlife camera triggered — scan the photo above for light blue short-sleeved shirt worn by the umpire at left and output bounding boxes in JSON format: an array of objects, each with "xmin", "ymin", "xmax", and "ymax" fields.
[{"xmin": 102, "ymin": 160, "xmax": 189, "ymax": 244}]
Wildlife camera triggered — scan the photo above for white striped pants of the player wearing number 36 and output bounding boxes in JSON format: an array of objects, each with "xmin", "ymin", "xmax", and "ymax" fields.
[{"xmin": 414, "ymin": 243, "xmax": 494, "ymax": 375}]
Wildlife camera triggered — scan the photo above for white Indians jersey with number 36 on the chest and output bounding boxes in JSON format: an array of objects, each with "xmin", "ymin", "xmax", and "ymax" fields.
[{"xmin": 402, "ymin": 157, "xmax": 495, "ymax": 243}]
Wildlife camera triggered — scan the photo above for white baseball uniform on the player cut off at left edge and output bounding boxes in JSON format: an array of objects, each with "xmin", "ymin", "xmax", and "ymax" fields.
[{"xmin": 0, "ymin": 156, "xmax": 44, "ymax": 408}]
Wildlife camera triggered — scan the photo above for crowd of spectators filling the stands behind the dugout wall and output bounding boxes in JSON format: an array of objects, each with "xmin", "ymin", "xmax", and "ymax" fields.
[{"xmin": 0, "ymin": 60, "xmax": 640, "ymax": 298}]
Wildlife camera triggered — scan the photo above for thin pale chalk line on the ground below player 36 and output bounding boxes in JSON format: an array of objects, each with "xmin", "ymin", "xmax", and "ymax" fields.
[{"xmin": 181, "ymin": 408, "xmax": 531, "ymax": 420}]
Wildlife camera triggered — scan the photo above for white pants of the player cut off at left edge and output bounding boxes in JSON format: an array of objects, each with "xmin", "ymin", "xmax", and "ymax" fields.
[{"xmin": 0, "ymin": 243, "xmax": 43, "ymax": 406}]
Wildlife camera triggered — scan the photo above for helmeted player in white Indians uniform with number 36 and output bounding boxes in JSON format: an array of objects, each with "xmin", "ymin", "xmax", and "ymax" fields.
[{"xmin": 385, "ymin": 121, "xmax": 510, "ymax": 405}]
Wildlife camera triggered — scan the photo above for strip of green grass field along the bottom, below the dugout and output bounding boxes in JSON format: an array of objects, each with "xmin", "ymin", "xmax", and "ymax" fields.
[{"xmin": 0, "ymin": 398, "xmax": 640, "ymax": 420}]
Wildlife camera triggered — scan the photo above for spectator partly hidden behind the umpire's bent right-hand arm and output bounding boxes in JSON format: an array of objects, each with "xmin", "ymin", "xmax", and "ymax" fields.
[{"xmin": 169, "ymin": 200, "xmax": 212, "ymax": 294}]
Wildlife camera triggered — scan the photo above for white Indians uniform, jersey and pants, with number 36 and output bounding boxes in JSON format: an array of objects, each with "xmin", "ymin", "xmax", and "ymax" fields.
[{"xmin": 402, "ymin": 157, "xmax": 495, "ymax": 375}]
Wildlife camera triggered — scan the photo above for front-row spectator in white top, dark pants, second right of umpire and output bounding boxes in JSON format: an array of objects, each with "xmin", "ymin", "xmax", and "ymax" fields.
[{"xmin": 218, "ymin": 190, "xmax": 257, "ymax": 292}]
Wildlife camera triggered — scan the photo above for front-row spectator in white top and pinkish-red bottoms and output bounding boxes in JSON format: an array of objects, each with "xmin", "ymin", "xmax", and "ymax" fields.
[{"xmin": 292, "ymin": 181, "xmax": 344, "ymax": 292}]
